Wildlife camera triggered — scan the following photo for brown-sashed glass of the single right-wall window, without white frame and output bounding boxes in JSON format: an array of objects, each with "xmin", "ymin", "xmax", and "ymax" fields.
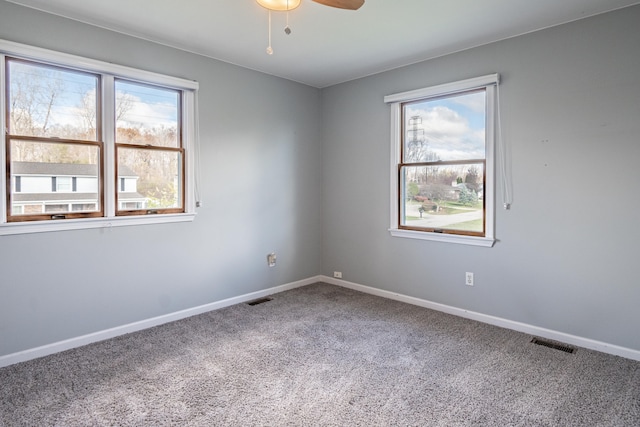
[{"xmin": 398, "ymin": 89, "xmax": 486, "ymax": 237}]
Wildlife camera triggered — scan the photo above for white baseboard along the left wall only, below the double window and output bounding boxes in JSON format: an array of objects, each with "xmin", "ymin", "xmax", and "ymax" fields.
[{"xmin": 0, "ymin": 276, "xmax": 323, "ymax": 368}]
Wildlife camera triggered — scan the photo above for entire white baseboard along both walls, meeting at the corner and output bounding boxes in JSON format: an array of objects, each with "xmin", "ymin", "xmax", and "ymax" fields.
[{"xmin": 0, "ymin": 275, "xmax": 640, "ymax": 368}]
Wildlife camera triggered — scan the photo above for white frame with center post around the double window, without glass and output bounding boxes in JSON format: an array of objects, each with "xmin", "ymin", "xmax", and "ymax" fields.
[{"xmin": 0, "ymin": 39, "xmax": 199, "ymax": 236}]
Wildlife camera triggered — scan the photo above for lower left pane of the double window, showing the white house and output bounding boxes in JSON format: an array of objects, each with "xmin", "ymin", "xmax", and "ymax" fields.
[{"xmin": 10, "ymin": 140, "xmax": 100, "ymax": 215}]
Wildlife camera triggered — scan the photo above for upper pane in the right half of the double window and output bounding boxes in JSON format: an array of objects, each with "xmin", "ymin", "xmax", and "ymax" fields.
[{"xmin": 115, "ymin": 80, "xmax": 180, "ymax": 148}]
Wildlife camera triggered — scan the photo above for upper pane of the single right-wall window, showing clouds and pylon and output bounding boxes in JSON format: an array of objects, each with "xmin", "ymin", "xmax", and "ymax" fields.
[{"xmin": 403, "ymin": 89, "xmax": 486, "ymax": 163}]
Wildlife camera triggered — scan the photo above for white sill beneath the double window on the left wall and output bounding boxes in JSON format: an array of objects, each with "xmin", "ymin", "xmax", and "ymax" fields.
[{"xmin": 0, "ymin": 213, "xmax": 196, "ymax": 236}]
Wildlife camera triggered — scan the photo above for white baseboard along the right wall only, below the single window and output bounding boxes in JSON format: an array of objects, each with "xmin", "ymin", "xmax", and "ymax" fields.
[{"xmin": 320, "ymin": 276, "xmax": 640, "ymax": 361}]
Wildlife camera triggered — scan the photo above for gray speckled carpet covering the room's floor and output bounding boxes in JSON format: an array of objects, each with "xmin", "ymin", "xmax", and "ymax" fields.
[{"xmin": 0, "ymin": 284, "xmax": 640, "ymax": 427}]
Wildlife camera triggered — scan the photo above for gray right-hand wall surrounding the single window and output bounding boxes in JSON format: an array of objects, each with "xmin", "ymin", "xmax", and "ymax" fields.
[{"xmin": 322, "ymin": 6, "xmax": 640, "ymax": 350}]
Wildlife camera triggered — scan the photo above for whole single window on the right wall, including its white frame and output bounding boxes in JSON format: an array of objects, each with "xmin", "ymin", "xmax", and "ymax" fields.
[{"xmin": 385, "ymin": 75, "xmax": 498, "ymax": 246}]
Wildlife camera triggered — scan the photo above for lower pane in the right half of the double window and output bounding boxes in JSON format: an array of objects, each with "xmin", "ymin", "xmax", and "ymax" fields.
[{"xmin": 118, "ymin": 147, "xmax": 182, "ymax": 210}]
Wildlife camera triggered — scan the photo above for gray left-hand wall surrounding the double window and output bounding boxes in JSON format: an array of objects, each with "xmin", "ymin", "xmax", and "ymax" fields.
[{"xmin": 0, "ymin": 1, "xmax": 321, "ymax": 356}]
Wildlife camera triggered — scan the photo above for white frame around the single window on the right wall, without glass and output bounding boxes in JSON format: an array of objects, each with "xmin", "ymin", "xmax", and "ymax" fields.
[{"xmin": 384, "ymin": 74, "xmax": 500, "ymax": 247}]
